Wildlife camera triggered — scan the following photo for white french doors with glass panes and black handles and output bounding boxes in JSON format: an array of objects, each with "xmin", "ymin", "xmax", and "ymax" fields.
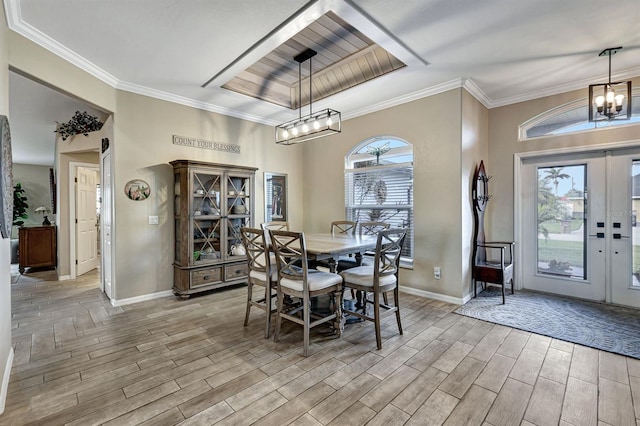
[{"xmin": 521, "ymin": 149, "xmax": 640, "ymax": 307}]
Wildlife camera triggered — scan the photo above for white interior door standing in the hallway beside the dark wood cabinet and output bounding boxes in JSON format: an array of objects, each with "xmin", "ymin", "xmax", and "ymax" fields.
[{"xmin": 76, "ymin": 167, "xmax": 99, "ymax": 276}]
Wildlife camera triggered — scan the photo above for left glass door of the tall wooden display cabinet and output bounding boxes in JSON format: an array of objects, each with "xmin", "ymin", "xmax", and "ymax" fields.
[{"xmin": 190, "ymin": 172, "xmax": 224, "ymax": 265}]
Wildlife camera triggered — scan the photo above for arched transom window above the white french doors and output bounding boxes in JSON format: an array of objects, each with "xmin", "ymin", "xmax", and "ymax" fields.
[{"xmin": 520, "ymin": 90, "xmax": 640, "ymax": 140}]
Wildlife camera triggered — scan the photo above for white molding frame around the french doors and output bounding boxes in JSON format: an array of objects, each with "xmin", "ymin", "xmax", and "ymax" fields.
[{"xmin": 513, "ymin": 139, "xmax": 640, "ymax": 299}]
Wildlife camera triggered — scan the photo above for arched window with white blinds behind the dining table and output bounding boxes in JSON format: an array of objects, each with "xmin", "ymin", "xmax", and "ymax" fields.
[{"xmin": 344, "ymin": 136, "xmax": 413, "ymax": 266}]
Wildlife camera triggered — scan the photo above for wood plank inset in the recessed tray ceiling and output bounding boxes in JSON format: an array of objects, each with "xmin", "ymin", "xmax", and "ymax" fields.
[{"xmin": 222, "ymin": 12, "xmax": 406, "ymax": 109}]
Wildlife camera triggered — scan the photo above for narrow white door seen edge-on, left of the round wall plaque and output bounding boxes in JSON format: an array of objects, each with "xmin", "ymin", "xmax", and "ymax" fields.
[{"xmin": 100, "ymin": 153, "xmax": 113, "ymax": 299}]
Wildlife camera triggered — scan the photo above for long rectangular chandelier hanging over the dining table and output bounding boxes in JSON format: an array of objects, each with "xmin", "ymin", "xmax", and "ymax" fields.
[{"xmin": 276, "ymin": 49, "xmax": 342, "ymax": 145}]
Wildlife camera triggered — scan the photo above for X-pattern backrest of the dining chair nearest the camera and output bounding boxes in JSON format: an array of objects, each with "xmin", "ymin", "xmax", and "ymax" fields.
[{"xmin": 269, "ymin": 230, "xmax": 308, "ymax": 292}]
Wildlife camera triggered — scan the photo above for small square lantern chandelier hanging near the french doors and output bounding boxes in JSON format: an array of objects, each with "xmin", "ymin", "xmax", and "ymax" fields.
[{"xmin": 589, "ymin": 47, "xmax": 631, "ymax": 121}]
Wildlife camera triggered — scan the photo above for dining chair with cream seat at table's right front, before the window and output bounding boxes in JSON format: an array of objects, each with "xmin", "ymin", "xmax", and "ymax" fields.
[{"xmin": 340, "ymin": 228, "xmax": 407, "ymax": 349}]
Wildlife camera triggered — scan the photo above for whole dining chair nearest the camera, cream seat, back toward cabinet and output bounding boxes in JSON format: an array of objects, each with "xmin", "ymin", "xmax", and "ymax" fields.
[{"xmin": 270, "ymin": 231, "xmax": 342, "ymax": 356}]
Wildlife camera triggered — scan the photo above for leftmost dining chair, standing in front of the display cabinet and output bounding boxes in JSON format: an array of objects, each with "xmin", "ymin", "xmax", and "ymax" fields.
[{"xmin": 240, "ymin": 227, "xmax": 278, "ymax": 339}]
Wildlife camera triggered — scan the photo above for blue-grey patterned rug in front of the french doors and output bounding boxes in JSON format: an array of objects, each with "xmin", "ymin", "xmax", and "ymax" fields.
[{"xmin": 455, "ymin": 287, "xmax": 640, "ymax": 359}]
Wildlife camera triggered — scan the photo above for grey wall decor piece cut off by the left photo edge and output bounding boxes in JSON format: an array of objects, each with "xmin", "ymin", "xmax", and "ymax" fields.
[{"xmin": 0, "ymin": 115, "xmax": 13, "ymax": 238}]
